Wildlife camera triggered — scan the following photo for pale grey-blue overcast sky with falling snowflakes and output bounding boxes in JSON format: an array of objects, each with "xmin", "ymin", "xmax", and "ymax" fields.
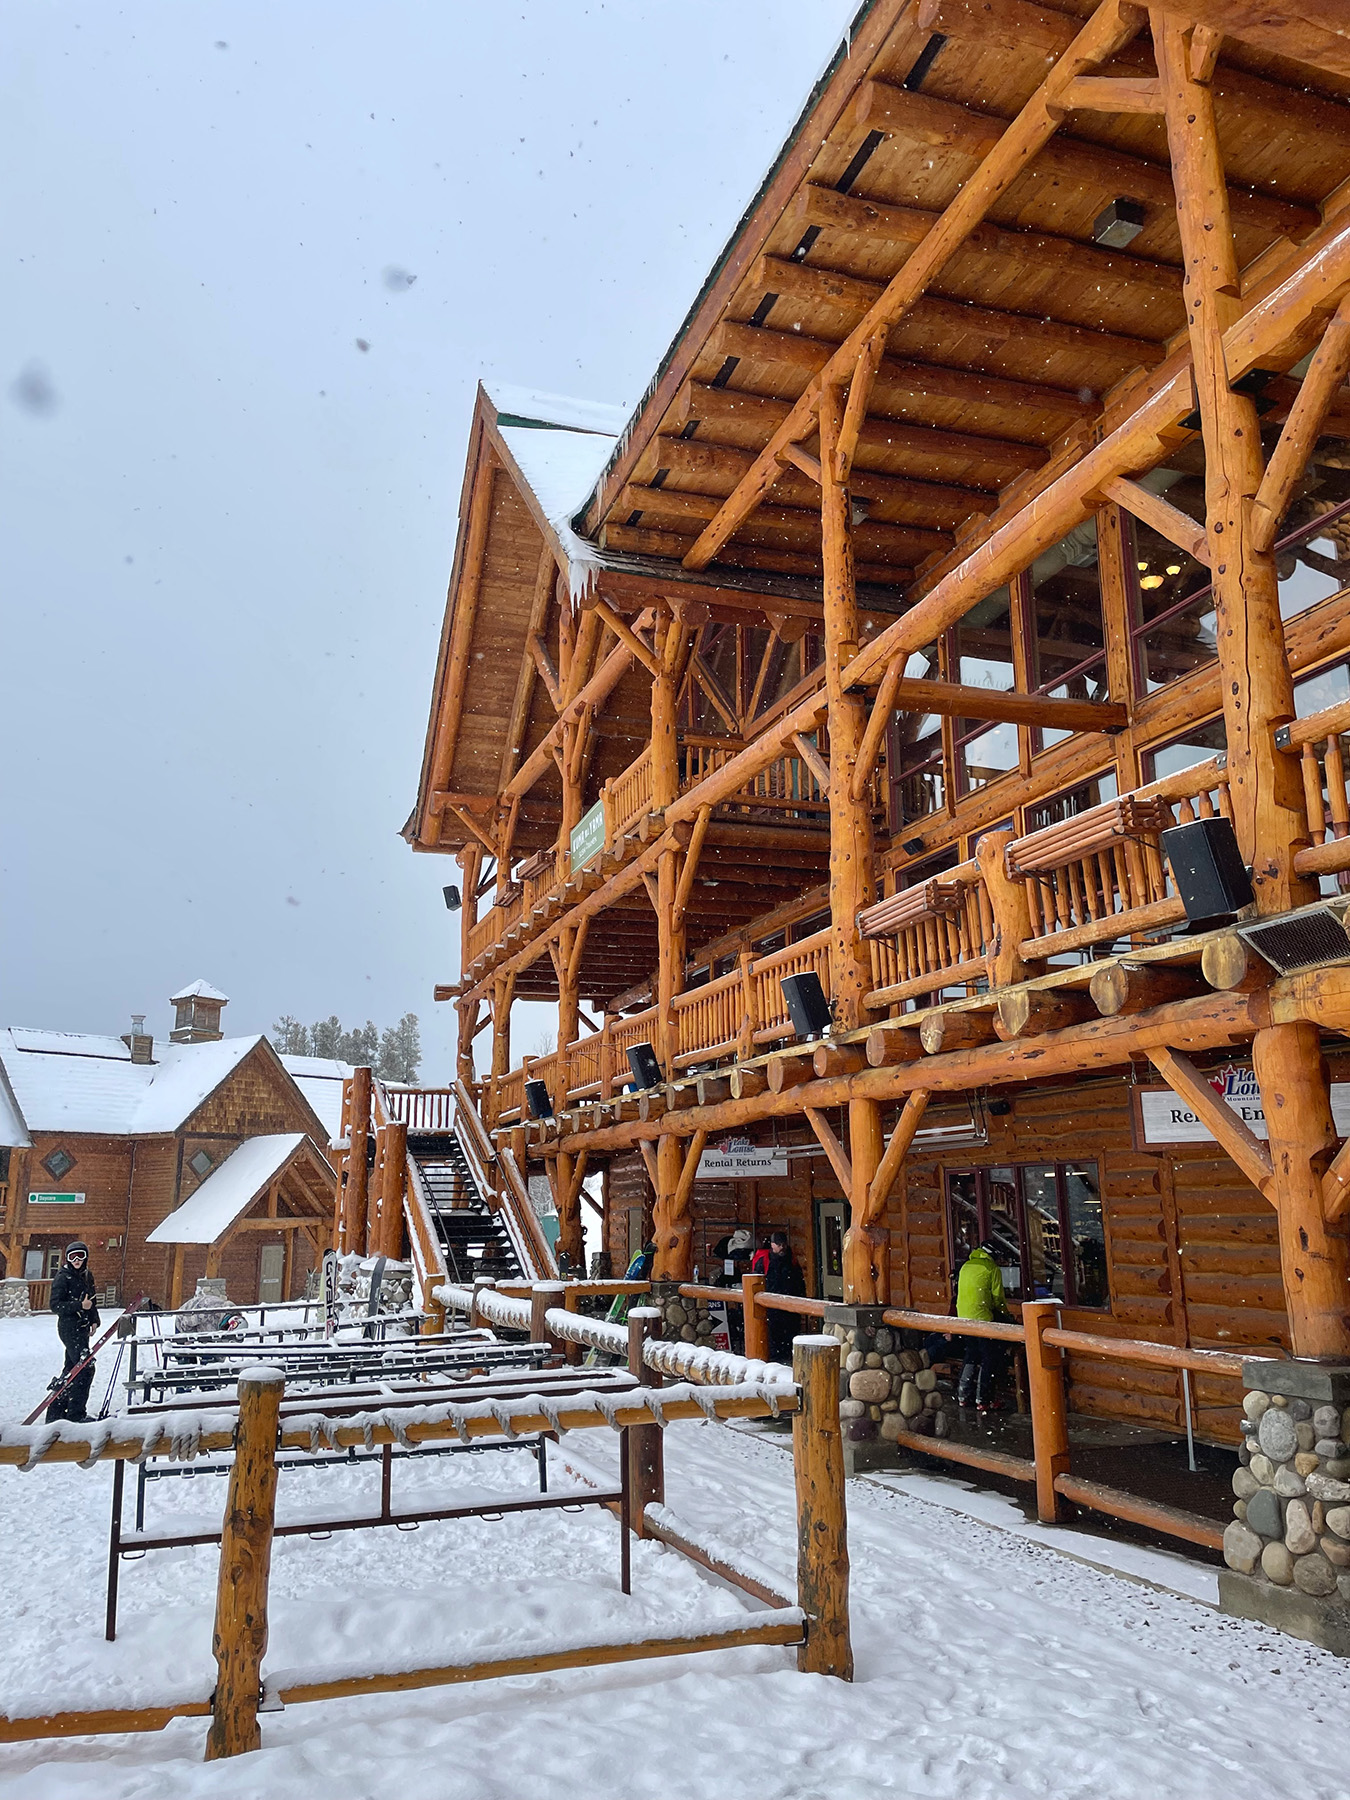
[{"xmin": 0, "ymin": 0, "xmax": 855, "ymax": 1080}]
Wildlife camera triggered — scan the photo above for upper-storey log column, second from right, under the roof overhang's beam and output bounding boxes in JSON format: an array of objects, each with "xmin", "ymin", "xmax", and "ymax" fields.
[{"xmin": 821, "ymin": 387, "xmax": 875, "ymax": 1031}]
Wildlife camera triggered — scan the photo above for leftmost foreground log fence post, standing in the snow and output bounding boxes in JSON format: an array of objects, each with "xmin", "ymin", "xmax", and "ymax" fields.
[{"xmin": 205, "ymin": 1366, "xmax": 286, "ymax": 1762}]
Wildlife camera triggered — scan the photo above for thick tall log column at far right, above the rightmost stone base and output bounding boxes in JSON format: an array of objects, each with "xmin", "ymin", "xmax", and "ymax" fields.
[{"xmin": 1150, "ymin": 9, "xmax": 1350, "ymax": 1355}]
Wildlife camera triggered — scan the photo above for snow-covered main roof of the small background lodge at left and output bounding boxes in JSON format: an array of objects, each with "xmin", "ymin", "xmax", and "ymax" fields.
[{"xmin": 0, "ymin": 1026, "xmax": 263, "ymax": 1136}]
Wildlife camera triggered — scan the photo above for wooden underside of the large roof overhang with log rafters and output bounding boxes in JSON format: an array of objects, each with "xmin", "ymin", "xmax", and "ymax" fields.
[{"xmin": 585, "ymin": 0, "xmax": 1350, "ymax": 635}]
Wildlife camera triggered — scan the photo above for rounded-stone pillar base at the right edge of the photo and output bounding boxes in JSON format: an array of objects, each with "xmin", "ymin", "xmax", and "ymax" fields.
[{"xmin": 1219, "ymin": 1357, "xmax": 1350, "ymax": 1656}]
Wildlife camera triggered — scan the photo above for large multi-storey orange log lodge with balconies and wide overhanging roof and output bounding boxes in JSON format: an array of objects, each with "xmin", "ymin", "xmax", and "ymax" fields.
[{"xmin": 405, "ymin": 0, "xmax": 1350, "ymax": 1442}]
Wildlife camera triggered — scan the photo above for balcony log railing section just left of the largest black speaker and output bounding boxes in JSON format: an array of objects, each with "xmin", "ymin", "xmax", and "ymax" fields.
[{"xmin": 1006, "ymin": 756, "xmax": 1228, "ymax": 961}]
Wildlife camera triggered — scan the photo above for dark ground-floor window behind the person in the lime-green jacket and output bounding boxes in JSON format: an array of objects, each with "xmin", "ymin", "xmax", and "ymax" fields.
[{"xmin": 947, "ymin": 1161, "xmax": 1111, "ymax": 1307}]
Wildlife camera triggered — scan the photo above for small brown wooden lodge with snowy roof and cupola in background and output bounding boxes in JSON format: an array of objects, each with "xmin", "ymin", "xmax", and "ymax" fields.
[{"xmin": 0, "ymin": 981, "xmax": 351, "ymax": 1309}]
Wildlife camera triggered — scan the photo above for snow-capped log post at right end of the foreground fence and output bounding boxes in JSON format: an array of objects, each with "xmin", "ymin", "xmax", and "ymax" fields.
[{"xmin": 792, "ymin": 1337, "xmax": 853, "ymax": 1681}]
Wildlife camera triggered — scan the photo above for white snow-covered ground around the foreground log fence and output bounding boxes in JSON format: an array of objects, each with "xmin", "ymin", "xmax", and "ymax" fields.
[{"xmin": 0, "ymin": 1319, "xmax": 1350, "ymax": 1800}]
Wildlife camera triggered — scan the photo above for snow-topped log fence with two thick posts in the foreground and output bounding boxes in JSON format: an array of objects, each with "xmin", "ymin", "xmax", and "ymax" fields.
[{"xmin": 0, "ymin": 1339, "xmax": 851, "ymax": 1760}]
